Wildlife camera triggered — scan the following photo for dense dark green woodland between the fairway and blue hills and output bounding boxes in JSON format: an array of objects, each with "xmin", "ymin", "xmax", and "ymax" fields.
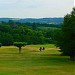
[{"xmin": 0, "ymin": 20, "xmax": 59, "ymax": 46}]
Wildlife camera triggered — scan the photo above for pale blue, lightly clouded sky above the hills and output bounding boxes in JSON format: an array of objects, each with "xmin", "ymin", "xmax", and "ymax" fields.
[{"xmin": 0, "ymin": 0, "xmax": 75, "ymax": 18}]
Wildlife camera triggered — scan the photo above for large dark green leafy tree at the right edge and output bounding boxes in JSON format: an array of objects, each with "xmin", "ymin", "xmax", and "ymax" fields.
[{"xmin": 57, "ymin": 8, "xmax": 75, "ymax": 60}]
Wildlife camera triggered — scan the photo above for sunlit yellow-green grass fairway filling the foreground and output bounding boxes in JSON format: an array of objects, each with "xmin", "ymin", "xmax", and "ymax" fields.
[{"xmin": 0, "ymin": 44, "xmax": 75, "ymax": 75}]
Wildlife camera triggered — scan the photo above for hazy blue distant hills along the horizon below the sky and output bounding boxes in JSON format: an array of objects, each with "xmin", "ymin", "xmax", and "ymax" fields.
[{"xmin": 0, "ymin": 18, "xmax": 64, "ymax": 24}]
